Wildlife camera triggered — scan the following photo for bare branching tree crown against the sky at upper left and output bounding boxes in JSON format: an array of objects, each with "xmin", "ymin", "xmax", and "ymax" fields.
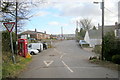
[{"xmin": 0, "ymin": 0, "xmax": 43, "ymax": 30}]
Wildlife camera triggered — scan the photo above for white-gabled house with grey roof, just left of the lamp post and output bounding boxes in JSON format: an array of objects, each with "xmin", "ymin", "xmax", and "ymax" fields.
[{"xmin": 84, "ymin": 30, "xmax": 102, "ymax": 47}]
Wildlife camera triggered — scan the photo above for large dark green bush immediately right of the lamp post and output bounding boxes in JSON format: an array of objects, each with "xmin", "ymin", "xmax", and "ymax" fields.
[{"xmin": 103, "ymin": 32, "xmax": 120, "ymax": 61}]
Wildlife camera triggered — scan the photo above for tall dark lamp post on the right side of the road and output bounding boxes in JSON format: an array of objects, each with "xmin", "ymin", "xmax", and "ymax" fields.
[{"xmin": 94, "ymin": 0, "xmax": 104, "ymax": 60}]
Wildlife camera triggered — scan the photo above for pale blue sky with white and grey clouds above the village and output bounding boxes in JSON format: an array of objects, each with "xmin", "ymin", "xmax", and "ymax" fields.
[{"xmin": 24, "ymin": 0, "xmax": 119, "ymax": 34}]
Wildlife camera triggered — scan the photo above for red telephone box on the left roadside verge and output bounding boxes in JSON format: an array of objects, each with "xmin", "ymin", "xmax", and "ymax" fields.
[{"xmin": 18, "ymin": 39, "xmax": 28, "ymax": 57}]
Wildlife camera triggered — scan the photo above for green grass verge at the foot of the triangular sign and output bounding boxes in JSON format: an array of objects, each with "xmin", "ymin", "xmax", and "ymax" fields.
[{"xmin": 2, "ymin": 52, "xmax": 32, "ymax": 78}]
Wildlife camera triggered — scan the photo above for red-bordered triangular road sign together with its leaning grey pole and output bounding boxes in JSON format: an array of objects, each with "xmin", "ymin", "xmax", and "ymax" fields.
[{"xmin": 3, "ymin": 22, "xmax": 16, "ymax": 64}]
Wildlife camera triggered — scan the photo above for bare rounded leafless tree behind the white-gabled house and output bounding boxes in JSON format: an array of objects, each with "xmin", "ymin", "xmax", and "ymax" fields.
[{"xmin": 80, "ymin": 19, "xmax": 92, "ymax": 30}]
